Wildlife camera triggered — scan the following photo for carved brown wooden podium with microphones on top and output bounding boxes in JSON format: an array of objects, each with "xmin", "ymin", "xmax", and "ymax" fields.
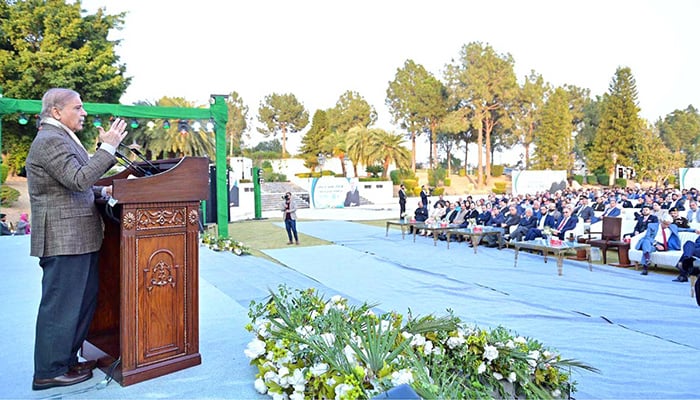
[{"xmin": 82, "ymin": 157, "xmax": 209, "ymax": 386}]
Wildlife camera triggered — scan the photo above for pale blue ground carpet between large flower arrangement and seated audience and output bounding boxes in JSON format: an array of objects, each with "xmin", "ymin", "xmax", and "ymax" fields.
[{"xmin": 266, "ymin": 221, "xmax": 700, "ymax": 399}]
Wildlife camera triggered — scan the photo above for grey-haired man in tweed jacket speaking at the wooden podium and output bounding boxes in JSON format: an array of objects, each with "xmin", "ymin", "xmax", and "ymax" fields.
[{"xmin": 26, "ymin": 88, "xmax": 127, "ymax": 390}]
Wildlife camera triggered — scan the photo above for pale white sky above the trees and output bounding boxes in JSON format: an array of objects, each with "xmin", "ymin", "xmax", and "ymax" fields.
[{"xmin": 82, "ymin": 0, "xmax": 700, "ymax": 162}]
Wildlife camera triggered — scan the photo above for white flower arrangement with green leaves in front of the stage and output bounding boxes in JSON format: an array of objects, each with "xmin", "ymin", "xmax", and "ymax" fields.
[{"xmin": 244, "ymin": 285, "xmax": 596, "ymax": 400}]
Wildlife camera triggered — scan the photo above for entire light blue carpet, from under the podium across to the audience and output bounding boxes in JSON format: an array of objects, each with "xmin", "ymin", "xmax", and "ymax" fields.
[{"xmin": 0, "ymin": 221, "xmax": 700, "ymax": 399}]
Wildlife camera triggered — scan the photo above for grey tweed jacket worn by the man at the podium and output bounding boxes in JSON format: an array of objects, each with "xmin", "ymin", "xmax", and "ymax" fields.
[{"xmin": 26, "ymin": 124, "xmax": 116, "ymax": 257}]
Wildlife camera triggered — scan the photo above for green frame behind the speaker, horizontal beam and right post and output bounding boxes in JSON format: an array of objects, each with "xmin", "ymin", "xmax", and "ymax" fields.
[{"xmin": 0, "ymin": 89, "xmax": 229, "ymax": 238}]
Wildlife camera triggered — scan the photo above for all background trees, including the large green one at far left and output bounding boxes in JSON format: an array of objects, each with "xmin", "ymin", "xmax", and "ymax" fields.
[{"xmin": 0, "ymin": 0, "xmax": 700, "ymax": 187}]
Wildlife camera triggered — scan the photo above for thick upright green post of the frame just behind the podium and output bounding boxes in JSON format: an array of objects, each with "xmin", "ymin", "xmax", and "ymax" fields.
[{"xmin": 210, "ymin": 95, "xmax": 229, "ymax": 239}]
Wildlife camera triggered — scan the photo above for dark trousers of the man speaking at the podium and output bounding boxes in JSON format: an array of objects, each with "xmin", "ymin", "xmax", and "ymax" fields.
[{"xmin": 34, "ymin": 252, "xmax": 99, "ymax": 379}]
